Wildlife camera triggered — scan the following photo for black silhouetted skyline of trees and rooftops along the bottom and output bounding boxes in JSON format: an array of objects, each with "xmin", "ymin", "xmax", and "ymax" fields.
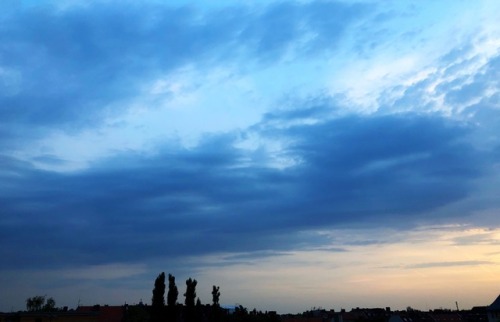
[{"xmin": 0, "ymin": 272, "xmax": 500, "ymax": 322}]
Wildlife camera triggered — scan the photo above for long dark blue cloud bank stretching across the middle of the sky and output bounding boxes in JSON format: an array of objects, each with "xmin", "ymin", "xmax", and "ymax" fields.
[{"xmin": 0, "ymin": 113, "xmax": 482, "ymax": 267}]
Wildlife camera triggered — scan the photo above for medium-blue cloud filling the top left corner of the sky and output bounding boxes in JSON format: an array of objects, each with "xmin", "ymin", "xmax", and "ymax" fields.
[{"xmin": 0, "ymin": 2, "xmax": 372, "ymax": 138}]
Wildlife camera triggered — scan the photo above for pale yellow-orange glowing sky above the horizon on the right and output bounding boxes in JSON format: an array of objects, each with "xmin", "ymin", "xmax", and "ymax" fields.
[{"xmin": 196, "ymin": 226, "xmax": 500, "ymax": 311}]
